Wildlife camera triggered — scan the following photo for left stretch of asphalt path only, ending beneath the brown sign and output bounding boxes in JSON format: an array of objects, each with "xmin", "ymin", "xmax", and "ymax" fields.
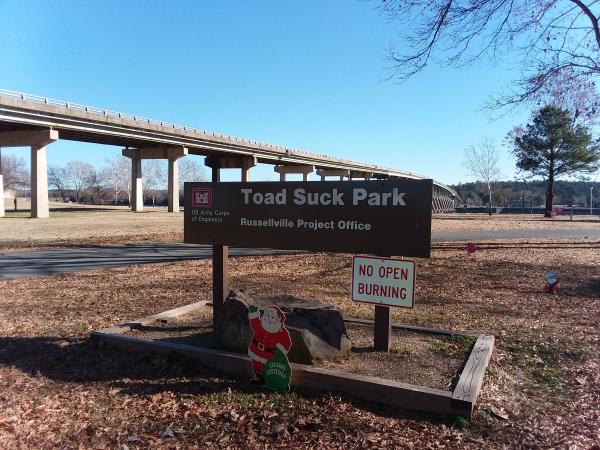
[{"xmin": 0, "ymin": 244, "xmax": 289, "ymax": 281}]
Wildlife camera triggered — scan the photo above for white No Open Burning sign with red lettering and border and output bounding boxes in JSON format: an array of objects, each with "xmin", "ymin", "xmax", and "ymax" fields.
[{"xmin": 352, "ymin": 256, "xmax": 416, "ymax": 308}]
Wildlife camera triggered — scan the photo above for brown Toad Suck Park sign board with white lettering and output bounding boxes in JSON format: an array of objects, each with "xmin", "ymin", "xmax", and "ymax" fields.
[{"xmin": 184, "ymin": 179, "xmax": 433, "ymax": 257}]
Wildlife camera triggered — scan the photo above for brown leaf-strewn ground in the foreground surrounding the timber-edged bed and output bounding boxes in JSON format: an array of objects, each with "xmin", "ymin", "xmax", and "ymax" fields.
[{"xmin": 0, "ymin": 240, "xmax": 600, "ymax": 449}]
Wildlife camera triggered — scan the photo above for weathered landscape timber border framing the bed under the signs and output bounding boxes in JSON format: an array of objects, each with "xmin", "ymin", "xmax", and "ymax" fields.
[{"xmin": 91, "ymin": 301, "xmax": 494, "ymax": 418}]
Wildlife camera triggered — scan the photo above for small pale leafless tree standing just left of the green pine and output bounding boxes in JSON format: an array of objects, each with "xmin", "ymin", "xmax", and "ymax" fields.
[{"xmin": 463, "ymin": 137, "xmax": 500, "ymax": 216}]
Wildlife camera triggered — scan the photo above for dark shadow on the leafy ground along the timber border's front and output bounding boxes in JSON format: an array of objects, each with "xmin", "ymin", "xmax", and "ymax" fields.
[{"xmin": 0, "ymin": 336, "xmax": 451, "ymax": 425}]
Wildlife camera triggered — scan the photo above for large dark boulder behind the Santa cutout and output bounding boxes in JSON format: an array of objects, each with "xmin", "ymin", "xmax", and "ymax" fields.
[{"xmin": 215, "ymin": 290, "xmax": 351, "ymax": 364}]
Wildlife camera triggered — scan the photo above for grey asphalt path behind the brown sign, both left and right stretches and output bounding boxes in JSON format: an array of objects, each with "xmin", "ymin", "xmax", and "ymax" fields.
[{"xmin": 0, "ymin": 227, "xmax": 600, "ymax": 281}]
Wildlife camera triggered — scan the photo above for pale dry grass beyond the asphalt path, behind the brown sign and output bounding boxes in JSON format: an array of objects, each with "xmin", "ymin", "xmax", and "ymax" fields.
[{"xmin": 0, "ymin": 208, "xmax": 600, "ymax": 252}]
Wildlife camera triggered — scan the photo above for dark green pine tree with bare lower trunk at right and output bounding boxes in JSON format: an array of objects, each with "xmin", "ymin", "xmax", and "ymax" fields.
[{"xmin": 511, "ymin": 106, "xmax": 600, "ymax": 217}]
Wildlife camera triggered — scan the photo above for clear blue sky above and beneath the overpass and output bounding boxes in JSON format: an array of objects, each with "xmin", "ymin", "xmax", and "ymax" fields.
[{"xmin": 0, "ymin": 0, "xmax": 528, "ymax": 183}]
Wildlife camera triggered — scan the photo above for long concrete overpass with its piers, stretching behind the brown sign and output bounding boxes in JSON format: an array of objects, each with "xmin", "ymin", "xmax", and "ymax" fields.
[{"xmin": 0, "ymin": 89, "xmax": 458, "ymax": 218}]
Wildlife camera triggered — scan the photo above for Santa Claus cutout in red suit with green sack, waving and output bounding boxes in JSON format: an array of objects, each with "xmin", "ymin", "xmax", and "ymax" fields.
[{"xmin": 248, "ymin": 305, "xmax": 292, "ymax": 391}]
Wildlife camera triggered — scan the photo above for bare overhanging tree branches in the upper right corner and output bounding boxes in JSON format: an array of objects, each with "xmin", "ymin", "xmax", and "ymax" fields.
[{"xmin": 378, "ymin": 0, "xmax": 600, "ymax": 107}]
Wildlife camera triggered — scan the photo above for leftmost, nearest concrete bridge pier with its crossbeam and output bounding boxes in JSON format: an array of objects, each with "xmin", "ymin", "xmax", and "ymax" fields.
[{"xmin": 0, "ymin": 129, "xmax": 58, "ymax": 219}]
